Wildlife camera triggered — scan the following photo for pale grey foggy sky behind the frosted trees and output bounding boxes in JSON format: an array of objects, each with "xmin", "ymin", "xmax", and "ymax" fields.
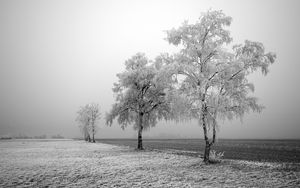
[{"xmin": 0, "ymin": 0, "xmax": 300, "ymax": 138}]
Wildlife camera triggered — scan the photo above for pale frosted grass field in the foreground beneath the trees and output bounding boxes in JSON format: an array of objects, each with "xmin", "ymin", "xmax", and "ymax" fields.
[{"xmin": 0, "ymin": 140, "xmax": 300, "ymax": 187}]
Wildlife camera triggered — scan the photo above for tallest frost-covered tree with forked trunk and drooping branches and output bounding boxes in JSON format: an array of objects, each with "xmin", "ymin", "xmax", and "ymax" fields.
[{"xmin": 163, "ymin": 11, "xmax": 276, "ymax": 163}]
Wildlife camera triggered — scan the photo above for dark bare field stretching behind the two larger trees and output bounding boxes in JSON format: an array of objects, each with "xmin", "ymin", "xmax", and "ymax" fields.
[{"xmin": 98, "ymin": 139, "xmax": 300, "ymax": 163}]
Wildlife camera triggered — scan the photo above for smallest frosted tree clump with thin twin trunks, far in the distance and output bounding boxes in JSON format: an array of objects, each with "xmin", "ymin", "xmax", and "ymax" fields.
[{"xmin": 76, "ymin": 103, "xmax": 101, "ymax": 142}]
